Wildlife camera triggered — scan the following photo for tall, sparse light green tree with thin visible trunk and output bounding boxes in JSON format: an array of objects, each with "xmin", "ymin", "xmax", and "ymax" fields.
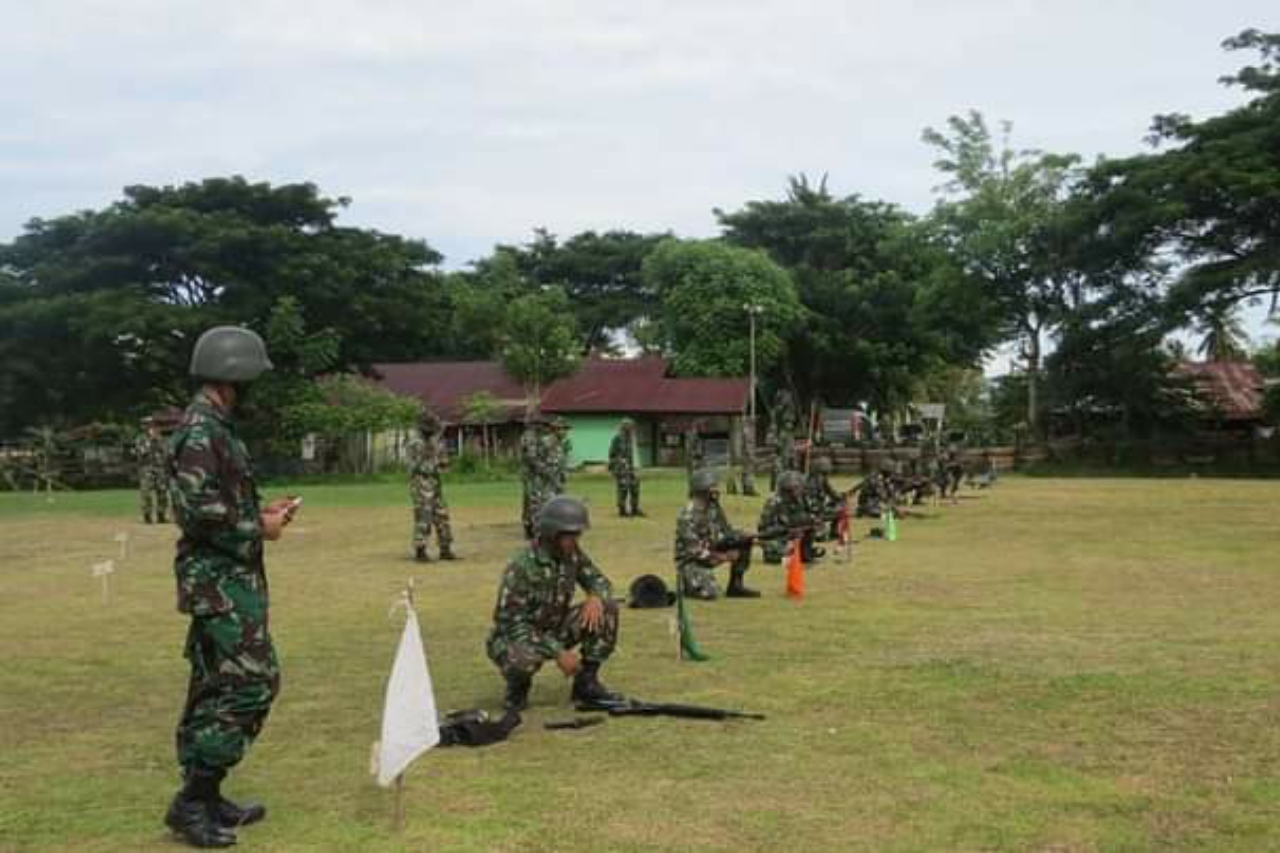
[{"xmin": 924, "ymin": 110, "xmax": 1087, "ymax": 432}]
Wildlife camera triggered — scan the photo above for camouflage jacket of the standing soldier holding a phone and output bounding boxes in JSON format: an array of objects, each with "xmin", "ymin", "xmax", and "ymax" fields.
[{"xmin": 169, "ymin": 392, "xmax": 266, "ymax": 616}]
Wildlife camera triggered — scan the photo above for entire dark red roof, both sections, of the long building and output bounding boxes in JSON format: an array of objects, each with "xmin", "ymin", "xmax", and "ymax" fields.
[{"xmin": 374, "ymin": 356, "xmax": 749, "ymax": 421}]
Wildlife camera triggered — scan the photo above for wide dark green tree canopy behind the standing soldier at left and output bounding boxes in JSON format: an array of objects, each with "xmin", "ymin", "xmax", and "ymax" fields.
[{"xmin": 0, "ymin": 177, "xmax": 449, "ymax": 433}]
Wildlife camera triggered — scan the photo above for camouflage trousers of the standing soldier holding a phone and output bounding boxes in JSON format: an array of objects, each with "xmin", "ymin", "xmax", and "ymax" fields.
[{"xmin": 177, "ymin": 585, "xmax": 280, "ymax": 772}]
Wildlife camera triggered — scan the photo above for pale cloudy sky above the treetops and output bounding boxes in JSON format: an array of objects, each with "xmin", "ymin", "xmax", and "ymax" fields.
[{"xmin": 0, "ymin": 0, "xmax": 1280, "ymax": 350}]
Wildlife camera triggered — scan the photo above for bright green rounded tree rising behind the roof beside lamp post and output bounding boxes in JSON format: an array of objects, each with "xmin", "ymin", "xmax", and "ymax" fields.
[{"xmin": 644, "ymin": 238, "xmax": 805, "ymax": 377}]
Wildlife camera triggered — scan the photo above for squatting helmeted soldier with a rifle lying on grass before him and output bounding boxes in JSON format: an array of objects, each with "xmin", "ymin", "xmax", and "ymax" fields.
[{"xmin": 485, "ymin": 496, "xmax": 622, "ymax": 711}]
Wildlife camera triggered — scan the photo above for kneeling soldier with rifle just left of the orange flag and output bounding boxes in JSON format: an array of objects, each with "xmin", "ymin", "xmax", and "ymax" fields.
[{"xmin": 676, "ymin": 467, "xmax": 760, "ymax": 601}]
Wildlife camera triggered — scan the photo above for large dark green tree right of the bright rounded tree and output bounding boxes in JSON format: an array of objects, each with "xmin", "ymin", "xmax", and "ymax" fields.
[{"xmin": 716, "ymin": 175, "xmax": 992, "ymax": 411}]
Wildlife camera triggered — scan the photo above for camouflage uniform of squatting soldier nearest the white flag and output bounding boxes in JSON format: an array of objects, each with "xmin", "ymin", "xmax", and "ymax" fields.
[{"xmin": 485, "ymin": 540, "xmax": 618, "ymax": 678}]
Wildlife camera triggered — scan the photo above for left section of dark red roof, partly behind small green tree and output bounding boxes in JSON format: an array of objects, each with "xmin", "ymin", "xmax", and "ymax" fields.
[{"xmin": 374, "ymin": 361, "xmax": 525, "ymax": 423}]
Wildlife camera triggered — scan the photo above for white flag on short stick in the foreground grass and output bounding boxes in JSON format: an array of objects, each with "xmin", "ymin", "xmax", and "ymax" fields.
[{"xmin": 378, "ymin": 607, "xmax": 440, "ymax": 788}]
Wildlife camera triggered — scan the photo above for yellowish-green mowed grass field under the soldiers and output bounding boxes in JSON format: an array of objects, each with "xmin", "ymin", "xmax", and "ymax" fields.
[{"xmin": 0, "ymin": 473, "xmax": 1280, "ymax": 850}]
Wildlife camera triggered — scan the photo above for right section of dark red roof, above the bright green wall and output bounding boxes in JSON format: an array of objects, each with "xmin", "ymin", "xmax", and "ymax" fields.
[{"xmin": 543, "ymin": 356, "xmax": 749, "ymax": 415}]
